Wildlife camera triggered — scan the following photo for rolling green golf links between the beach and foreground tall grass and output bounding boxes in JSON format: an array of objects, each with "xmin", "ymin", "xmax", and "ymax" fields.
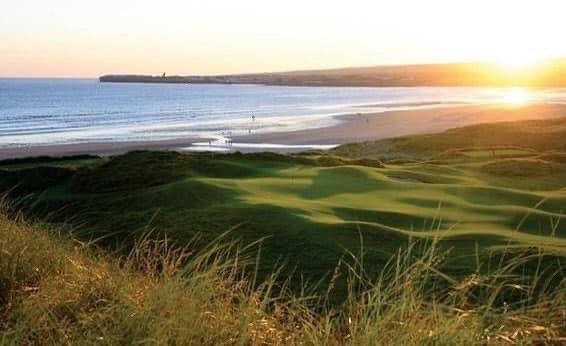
[{"xmin": 0, "ymin": 120, "xmax": 566, "ymax": 290}]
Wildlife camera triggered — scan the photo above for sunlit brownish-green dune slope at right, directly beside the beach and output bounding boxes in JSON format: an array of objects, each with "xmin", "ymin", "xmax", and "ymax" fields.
[{"xmin": 334, "ymin": 118, "xmax": 566, "ymax": 159}]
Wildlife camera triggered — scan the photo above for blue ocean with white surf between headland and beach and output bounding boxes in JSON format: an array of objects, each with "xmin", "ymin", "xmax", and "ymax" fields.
[{"xmin": 0, "ymin": 79, "xmax": 566, "ymax": 148}]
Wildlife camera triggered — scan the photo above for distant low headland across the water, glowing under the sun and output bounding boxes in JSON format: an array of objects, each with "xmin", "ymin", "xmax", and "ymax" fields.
[{"xmin": 100, "ymin": 58, "xmax": 566, "ymax": 87}]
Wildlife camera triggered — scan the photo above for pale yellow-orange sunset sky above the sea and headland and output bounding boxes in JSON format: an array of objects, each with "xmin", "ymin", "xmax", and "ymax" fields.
[{"xmin": 0, "ymin": 0, "xmax": 566, "ymax": 77}]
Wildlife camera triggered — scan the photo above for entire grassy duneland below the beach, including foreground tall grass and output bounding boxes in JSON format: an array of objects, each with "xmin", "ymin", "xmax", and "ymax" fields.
[{"xmin": 0, "ymin": 119, "xmax": 566, "ymax": 344}]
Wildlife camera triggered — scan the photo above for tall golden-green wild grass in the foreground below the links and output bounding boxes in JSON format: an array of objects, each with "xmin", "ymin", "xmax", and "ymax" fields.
[{"xmin": 0, "ymin": 207, "xmax": 566, "ymax": 345}]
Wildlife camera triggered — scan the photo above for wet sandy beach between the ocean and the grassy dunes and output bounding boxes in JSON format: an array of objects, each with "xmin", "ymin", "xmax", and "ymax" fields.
[{"xmin": 0, "ymin": 104, "xmax": 566, "ymax": 159}]
